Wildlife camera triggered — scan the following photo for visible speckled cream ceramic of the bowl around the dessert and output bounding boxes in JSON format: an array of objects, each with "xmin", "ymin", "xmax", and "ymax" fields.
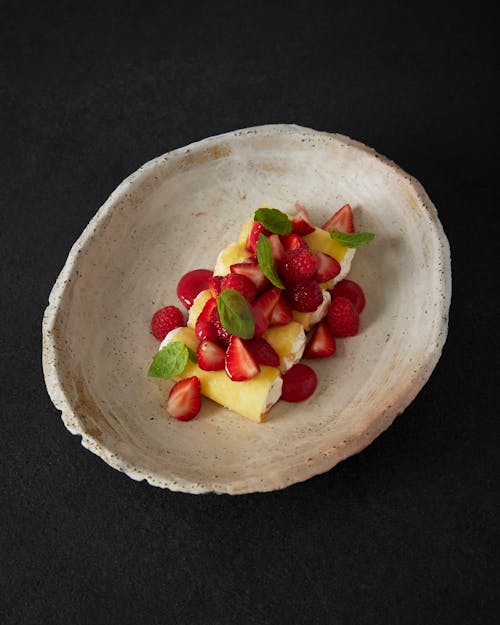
[{"xmin": 43, "ymin": 125, "xmax": 451, "ymax": 494}]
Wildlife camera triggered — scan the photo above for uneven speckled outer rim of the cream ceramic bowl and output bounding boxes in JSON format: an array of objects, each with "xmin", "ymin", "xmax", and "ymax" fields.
[{"xmin": 42, "ymin": 124, "xmax": 452, "ymax": 494}]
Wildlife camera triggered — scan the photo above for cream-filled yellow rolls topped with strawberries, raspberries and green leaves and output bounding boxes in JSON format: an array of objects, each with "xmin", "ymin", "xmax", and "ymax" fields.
[{"xmin": 149, "ymin": 202, "xmax": 374, "ymax": 423}]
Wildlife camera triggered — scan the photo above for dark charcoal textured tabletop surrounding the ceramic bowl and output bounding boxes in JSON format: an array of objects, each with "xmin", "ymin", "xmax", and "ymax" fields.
[{"xmin": 0, "ymin": 0, "xmax": 500, "ymax": 625}]
